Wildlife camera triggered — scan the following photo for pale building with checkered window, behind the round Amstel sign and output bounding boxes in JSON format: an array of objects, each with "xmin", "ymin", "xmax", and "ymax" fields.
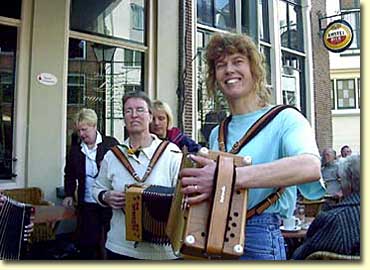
[{"xmin": 327, "ymin": 0, "xmax": 361, "ymax": 154}]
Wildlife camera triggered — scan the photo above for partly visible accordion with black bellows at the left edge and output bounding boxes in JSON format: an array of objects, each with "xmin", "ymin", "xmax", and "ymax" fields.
[{"xmin": 0, "ymin": 196, "xmax": 35, "ymax": 260}]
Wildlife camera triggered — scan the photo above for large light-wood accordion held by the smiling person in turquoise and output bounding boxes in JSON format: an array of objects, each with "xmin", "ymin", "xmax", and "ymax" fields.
[{"xmin": 167, "ymin": 148, "xmax": 251, "ymax": 259}]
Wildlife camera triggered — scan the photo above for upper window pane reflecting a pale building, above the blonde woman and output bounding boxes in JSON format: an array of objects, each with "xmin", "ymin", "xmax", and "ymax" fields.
[{"xmin": 70, "ymin": 0, "xmax": 146, "ymax": 43}]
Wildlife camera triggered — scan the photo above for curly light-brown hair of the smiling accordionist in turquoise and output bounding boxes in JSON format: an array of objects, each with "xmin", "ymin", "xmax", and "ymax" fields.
[{"xmin": 205, "ymin": 33, "xmax": 271, "ymax": 103}]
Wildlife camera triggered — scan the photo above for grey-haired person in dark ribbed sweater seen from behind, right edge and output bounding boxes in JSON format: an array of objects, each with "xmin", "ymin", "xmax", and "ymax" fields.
[{"xmin": 292, "ymin": 155, "xmax": 360, "ymax": 260}]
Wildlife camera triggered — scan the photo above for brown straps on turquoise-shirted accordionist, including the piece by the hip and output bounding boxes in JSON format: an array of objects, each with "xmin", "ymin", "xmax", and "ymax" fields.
[{"xmin": 218, "ymin": 105, "xmax": 298, "ymax": 219}]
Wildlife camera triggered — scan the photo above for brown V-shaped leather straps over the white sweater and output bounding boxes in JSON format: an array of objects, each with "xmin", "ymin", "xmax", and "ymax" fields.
[{"xmin": 111, "ymin": 141, "xmax": 170, "ymax": 183}]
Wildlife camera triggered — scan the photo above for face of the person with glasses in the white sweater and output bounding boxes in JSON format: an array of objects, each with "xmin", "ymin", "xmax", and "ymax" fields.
[{"xmin": 123, "ymin": 98, "xmax": 152, "ymax": 135}]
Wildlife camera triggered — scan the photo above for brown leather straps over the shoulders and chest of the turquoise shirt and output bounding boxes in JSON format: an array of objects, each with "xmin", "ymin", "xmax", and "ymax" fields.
[{"xmin": 218, "ymin": 105, "xmax": 298, "ymax": 154}]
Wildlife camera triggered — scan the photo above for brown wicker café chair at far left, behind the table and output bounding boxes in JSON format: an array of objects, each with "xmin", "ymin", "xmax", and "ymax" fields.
[{"xmin": 3, "ymin": 187, "xmax": 55, "ymax": 243}]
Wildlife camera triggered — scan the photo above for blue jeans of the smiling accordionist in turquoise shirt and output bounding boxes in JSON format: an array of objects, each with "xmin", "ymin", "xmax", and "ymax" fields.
[{"xmin": 240, "ymin": 213, "xmax": 286, "ymax": 260}]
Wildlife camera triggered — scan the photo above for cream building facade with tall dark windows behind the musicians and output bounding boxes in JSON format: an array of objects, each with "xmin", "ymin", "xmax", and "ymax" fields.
[{"xmin": 0, "ymin": 0, "xmax": 332, "ymax": 200}]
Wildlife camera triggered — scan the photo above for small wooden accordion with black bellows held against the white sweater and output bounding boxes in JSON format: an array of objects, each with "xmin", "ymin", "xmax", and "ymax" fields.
[{"xmin": 125, "ymin": 185, "xmax": 174, "ymax": 245}]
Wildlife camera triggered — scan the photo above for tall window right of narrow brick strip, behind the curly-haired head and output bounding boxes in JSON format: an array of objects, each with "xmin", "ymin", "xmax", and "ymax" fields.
[{"xmin": 195, "ymin": 0, "xmax": 258, "ymax": 145}]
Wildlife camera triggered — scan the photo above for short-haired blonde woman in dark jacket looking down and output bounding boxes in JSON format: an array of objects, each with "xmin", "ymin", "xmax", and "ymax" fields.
[{"xmin": 63, "ymin": 109, "xmax": 118, "ymax": 260}]
